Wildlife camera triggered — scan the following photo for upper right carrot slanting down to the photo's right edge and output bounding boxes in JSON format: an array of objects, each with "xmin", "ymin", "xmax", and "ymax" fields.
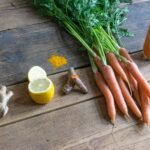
[{"xmin": 126, "ymin": 62, "xmax": 150, "ymax": 96}]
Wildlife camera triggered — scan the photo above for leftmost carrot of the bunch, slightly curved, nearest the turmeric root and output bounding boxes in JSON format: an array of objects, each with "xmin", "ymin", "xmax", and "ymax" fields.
[{"xmin": 94, "ymin": 72, "xmax": 116, "ymax": 124}]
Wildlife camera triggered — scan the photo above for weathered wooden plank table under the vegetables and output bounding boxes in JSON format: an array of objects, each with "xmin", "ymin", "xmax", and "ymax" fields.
[{"xmin": 0, "ymin": 0, "xmax": 150, "ymax": 150}]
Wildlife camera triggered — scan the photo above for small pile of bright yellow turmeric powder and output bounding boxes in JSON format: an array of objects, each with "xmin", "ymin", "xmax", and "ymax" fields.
[{"xmin": 48, "ymin": 55, "xmax": 67, "ymax": 68}]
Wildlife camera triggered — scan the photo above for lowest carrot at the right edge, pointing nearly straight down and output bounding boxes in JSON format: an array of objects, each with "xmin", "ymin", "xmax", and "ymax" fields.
[{"xmin": 140, "ymin": 88, "xmax": 150, "ymax": 126}]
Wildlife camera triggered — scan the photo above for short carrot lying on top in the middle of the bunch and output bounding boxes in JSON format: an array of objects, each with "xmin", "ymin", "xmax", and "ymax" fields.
[{"xmin": 106, "ymin": 53, "xmax": 128, "ymax": 83}]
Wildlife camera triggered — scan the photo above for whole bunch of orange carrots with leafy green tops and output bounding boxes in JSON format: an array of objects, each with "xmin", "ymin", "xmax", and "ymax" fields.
[{"xmin": 33, "ymin": 0, "xmax": 150, "ymax": 126}]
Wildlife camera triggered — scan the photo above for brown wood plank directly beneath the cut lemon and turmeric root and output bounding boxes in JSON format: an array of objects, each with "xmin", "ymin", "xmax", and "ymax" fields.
[{"xmin": 0, "ymin": 53, "xmax": 150, "ymax": 126}]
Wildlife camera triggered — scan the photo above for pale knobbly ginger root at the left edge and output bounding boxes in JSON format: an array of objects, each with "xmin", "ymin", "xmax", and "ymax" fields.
[{"xmin": 0, "ymin": 86, "xmax": 13, "ymax": 117}]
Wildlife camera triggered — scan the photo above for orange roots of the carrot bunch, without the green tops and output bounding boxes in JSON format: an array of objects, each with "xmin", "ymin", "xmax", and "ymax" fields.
[{"xmin": 91, "ymin": 48, "xmax": 150, "ymax": 125}]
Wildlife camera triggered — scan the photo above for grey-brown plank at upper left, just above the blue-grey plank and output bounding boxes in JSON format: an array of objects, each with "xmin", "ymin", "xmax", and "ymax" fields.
[{"xmin": 0, "ymin": 7, "xmax": 48, "ymax": 31}]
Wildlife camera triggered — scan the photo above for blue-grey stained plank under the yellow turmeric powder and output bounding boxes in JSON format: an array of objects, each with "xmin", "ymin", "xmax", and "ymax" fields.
[{"xmin": 0, "ymin": 2, "xmax": 150, "ymax": 85}]
